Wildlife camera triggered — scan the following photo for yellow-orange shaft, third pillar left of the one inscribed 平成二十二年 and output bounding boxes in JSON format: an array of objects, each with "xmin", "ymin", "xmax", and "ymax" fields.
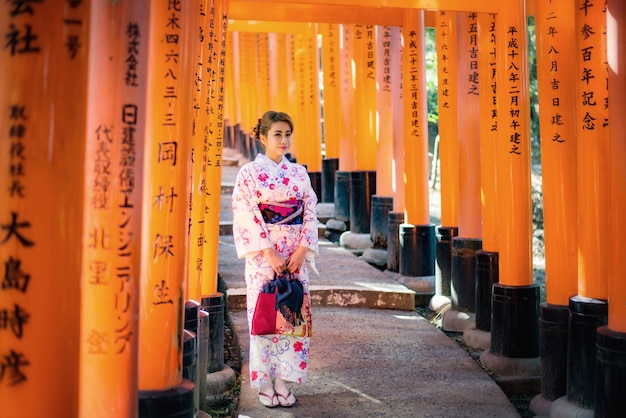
[{"xmin": 353, "ymin": 25, "xmax": 377, "ymax": 170}]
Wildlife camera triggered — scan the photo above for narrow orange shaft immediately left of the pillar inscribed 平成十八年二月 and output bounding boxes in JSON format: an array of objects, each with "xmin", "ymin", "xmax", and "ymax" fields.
[{"xmin": 478, "ymin": 13, "xmax": 503, "ymax": 252}]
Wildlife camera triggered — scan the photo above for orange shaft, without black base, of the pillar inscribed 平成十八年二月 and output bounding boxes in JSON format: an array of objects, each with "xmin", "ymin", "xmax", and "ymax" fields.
[{"xmin": 496, "ymin": 0, "xmax": 533, "ymax": 286}]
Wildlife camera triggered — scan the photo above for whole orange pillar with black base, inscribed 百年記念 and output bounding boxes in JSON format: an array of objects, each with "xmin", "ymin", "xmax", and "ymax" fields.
[{"xmin": 567, "ymin": 0, "xmax": 612, "ymax": 410}]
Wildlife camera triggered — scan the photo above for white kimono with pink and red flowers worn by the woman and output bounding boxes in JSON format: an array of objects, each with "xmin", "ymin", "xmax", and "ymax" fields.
[{"xmin": 232, "ymin": 154, "xmax": 318, "ymax": 388}]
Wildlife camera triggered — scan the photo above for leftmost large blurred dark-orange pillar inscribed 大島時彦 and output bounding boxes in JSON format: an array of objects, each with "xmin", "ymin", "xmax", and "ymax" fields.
[{"xmin": 0, "ymin": 2, "xmax": 90, "ymax": 418}]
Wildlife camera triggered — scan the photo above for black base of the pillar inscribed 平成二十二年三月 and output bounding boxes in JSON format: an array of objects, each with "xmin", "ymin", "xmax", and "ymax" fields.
[{"xmin": 399, "ymin": 223, "xmax": 435, "ymax": 277}]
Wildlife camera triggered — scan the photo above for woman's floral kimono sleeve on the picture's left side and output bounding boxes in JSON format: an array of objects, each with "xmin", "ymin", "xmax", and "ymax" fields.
[{"xmin": 232, "ymin": 165, "xmax": 272, "ymax": 258}]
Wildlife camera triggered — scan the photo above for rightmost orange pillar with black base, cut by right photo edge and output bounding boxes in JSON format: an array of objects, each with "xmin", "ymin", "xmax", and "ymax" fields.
[{"xmin": 594, "ymin": 0, "xmax": 626, "ymax": 416}]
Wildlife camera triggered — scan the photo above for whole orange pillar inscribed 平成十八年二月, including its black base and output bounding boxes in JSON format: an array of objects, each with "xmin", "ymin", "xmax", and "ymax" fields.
[{"xmin": 481, "ymin": 0, "xmax": 539, "ymax": 366}]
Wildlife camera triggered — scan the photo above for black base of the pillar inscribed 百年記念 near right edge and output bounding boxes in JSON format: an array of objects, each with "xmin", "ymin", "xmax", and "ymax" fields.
[{"xmin": 567, "ymin": 295, "xmax": 608, "ymax": 409}]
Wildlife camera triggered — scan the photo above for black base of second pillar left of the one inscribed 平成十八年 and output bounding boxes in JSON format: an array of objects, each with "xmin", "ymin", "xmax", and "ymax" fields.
[{"xmin": 450, "ymin": 237, "xmax": 483, "ymax": 312}]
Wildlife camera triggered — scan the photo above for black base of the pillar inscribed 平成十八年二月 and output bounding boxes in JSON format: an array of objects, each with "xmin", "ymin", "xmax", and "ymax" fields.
[{"xmin": 491, "ymin": 283, "xmax": 539, "ymax": 358}]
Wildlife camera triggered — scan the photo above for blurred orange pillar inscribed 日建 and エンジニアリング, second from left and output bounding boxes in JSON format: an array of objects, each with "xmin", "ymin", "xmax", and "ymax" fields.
[{"xmin": 79, "ymin": 1, "xmax": 150, "ymax": 417}]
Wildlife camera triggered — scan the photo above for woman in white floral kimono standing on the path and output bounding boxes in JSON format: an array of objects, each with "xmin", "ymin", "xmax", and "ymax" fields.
[{"xmin": 232, "ymin": 111, "xmax": 318, "ymax": 408}]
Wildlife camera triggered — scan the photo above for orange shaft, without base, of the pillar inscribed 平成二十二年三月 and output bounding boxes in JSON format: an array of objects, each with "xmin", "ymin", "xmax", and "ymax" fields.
[{"xmin": 402, "ymin": 10, "xmax": 430, "ymax": 225}]
